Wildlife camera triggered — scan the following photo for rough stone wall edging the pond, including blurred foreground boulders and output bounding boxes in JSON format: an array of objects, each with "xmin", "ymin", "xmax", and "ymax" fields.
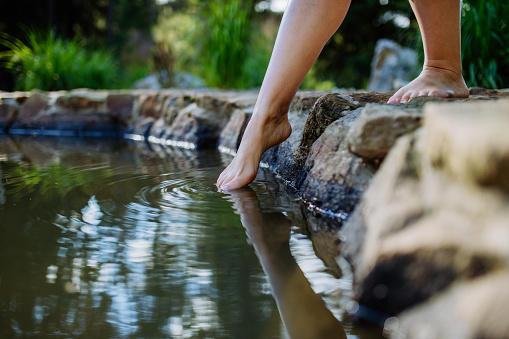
[{"xmin": 0, "ymin": 88, "xmax": 509, "ymax": 338}]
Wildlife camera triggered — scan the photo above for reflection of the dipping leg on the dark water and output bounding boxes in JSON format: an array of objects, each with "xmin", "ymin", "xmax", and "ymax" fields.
[{"xmin": 223, "ymin": 188, "xmax": 346, "ymax": 339}]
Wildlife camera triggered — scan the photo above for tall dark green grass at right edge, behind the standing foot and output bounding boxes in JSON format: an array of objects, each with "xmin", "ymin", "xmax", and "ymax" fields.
[{"xmin": 461, "ymin": 0, "xmax": 509, "ymax": 88}]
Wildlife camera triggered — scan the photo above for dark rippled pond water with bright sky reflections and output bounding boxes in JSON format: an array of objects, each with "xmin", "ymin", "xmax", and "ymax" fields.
[{"xmin": 0, "ymin": 136, "xmax": 380, "ymax": 338}]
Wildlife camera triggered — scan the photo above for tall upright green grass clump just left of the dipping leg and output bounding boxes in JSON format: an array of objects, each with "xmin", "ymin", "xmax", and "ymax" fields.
[{"xmin": 200, "ymin": 0, "xmax": 252, "ymax": 88}]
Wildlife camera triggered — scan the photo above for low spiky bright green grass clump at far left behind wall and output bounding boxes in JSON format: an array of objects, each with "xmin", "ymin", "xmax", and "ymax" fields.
[{"xmin": 0, "ymin": 32, "xmax": 118, "ymax": 91}]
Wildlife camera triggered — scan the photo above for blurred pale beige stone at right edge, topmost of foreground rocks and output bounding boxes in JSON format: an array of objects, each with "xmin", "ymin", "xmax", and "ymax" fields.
[{"xmin": 424, "ymin": 100, "xmax": 509, "ymax": 191}]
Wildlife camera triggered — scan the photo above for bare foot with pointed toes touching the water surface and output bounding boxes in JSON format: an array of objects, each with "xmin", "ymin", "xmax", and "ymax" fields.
[{"xmin": 217, "ymin": 114, "xmax": 292, "ymax": 190}]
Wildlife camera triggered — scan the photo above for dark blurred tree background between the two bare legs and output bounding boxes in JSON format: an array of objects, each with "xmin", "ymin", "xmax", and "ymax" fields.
[{"xmin": 314, "ymin": 0, "xmax": 418, "ymax": 88}]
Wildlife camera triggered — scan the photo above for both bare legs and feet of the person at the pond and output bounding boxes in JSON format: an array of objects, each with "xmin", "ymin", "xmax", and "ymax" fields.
[{"xmin": 217, "ymin": 0, "xmax": 468, "ymax": 191}]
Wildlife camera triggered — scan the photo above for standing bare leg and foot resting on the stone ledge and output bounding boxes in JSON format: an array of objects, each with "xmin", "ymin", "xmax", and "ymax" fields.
[{"xmin": 389, "ymin": 0, "xmax": 468, "ymax": 103}]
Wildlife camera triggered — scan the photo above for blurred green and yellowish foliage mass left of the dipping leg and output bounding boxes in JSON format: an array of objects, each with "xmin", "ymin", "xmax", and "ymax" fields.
[{"xmin": 152, "ymin": 2, "xmax": 277, "ymax": 88}]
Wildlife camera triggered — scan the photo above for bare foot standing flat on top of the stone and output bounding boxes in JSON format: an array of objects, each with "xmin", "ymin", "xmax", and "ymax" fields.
[{"xmin": 388, "ymin": 66, "xmax": 468, "ymax": 104}]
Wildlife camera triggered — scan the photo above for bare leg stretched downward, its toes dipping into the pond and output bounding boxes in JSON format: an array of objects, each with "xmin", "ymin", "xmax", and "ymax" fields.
[{"xmin": 217, "ymin": 0, "xmax": 350, "ymax": 190}]
